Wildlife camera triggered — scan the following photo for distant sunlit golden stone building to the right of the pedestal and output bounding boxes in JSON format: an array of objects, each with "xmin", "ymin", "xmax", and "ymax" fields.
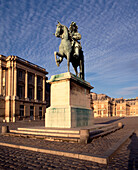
[{"xmin": 91, "ymin": 93, "xmax": 138, "ymax": 117}]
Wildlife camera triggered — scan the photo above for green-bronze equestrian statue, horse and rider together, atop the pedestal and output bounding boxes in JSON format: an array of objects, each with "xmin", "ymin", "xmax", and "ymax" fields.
[{"xmin": 54, "ymin": 22, "xmax": 84, "ymax": 80}]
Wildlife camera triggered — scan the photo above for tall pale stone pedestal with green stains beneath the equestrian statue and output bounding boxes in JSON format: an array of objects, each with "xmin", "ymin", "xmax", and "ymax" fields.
[{"xmin": 45, "ymin": 72, "xmax": 94, "ymax": 128}]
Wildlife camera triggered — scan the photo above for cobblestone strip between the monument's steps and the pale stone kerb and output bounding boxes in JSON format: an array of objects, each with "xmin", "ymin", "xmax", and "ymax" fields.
[{"xmin": 0, "ymin": 125, "xmax": 133, "ymax": 155}]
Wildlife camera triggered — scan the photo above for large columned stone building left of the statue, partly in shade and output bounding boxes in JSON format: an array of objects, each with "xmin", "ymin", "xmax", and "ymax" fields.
[{"xmin": 0, "ymin": 55, "xmax": 49, "ymax": 122}]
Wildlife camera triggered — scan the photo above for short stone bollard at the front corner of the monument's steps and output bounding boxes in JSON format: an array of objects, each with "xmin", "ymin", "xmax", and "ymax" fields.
[{"xmin": 80, "ymin": 129, "xmax": 90, "ymax": 144}]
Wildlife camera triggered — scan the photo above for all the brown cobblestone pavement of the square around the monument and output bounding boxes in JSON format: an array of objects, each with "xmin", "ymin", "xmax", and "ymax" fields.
[{"xmin": 0, "ymin": 117, "xmax": 138, "ymax": 169}]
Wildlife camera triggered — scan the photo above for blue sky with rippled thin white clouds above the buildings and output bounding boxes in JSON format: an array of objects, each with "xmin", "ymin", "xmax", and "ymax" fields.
[{"xmin": 0, "ymin": 0, "xmax": 138, "ymax": 98}]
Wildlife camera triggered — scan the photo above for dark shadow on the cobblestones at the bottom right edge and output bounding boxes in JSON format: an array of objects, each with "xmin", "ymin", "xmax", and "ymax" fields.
[{"xmin": 128, "ymin": 133, "xmax": 138, "ymax": 170}]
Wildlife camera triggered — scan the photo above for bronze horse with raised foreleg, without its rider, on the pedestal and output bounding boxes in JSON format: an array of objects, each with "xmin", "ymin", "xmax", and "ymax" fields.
[{"xmin": 54, "ymin": 22, "xmax": 84, "ymax": 80}]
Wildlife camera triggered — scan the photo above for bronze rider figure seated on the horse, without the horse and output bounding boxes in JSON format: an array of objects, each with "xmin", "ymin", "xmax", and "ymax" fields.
[{"xmin": 69, "ymin": 21, "xmax": 82, "ymax": 58}]
